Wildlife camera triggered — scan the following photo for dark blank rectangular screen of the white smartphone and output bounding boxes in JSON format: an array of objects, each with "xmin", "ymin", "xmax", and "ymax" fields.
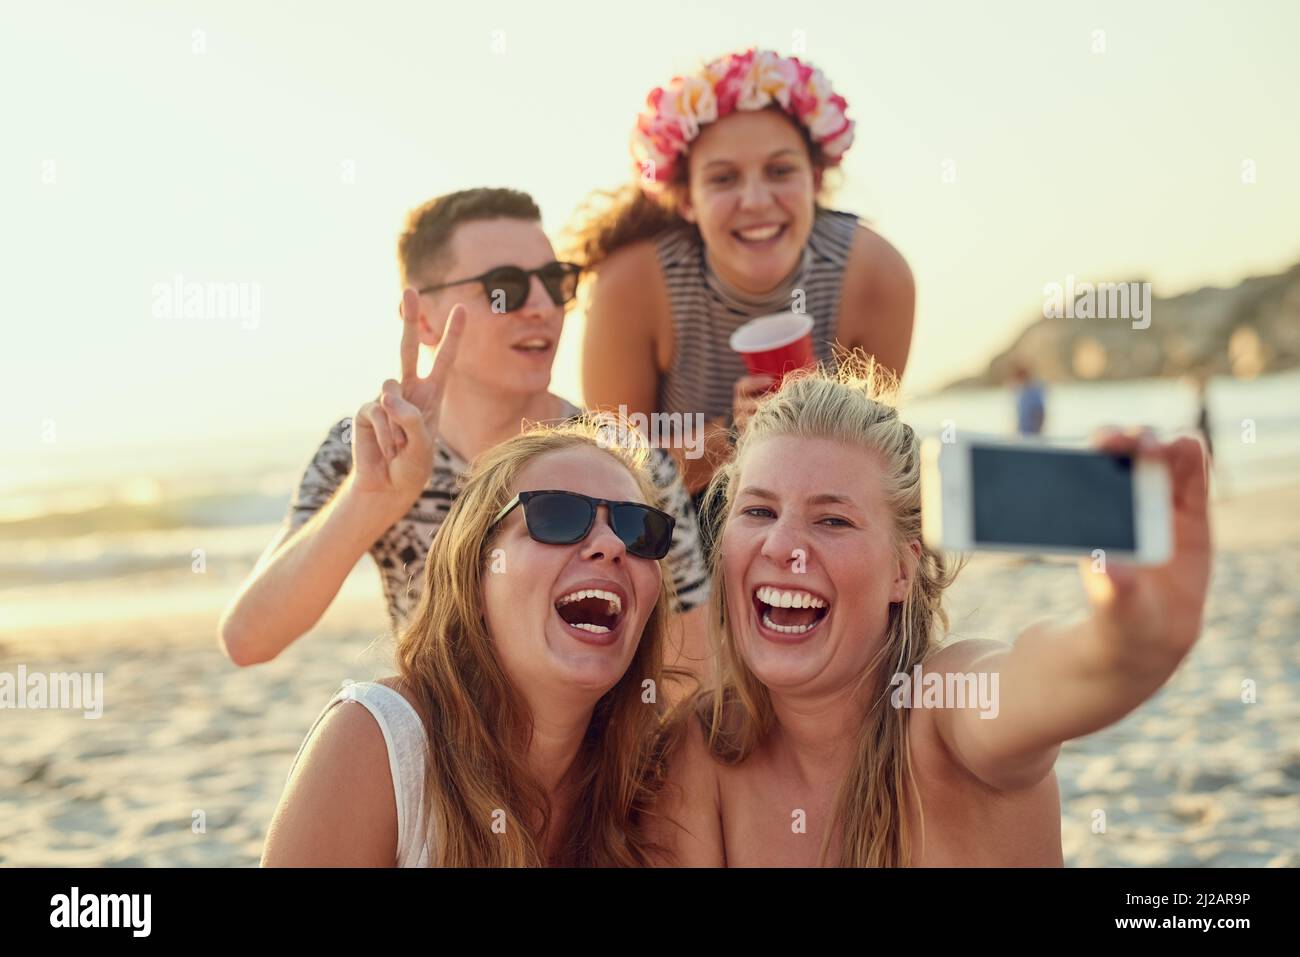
[{"xmin": 971, "ymin": 445, "xmax": 1136, "ymax": 551}]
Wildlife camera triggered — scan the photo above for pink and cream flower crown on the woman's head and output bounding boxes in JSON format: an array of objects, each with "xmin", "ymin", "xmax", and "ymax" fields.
[{"xmin": 632, "ymin": 49, "xmax": 853, "ymax": 194}]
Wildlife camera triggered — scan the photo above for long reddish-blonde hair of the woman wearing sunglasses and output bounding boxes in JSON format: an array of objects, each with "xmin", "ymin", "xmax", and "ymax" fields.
[{"xmin": 397, "ymin": 419, "xmax": 672, "ymax": 867}]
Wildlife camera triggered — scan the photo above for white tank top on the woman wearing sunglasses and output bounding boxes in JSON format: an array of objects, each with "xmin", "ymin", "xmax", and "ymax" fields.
[{"xmin": 289, "ymin": 681, "xmax": 429, "ymax": 867}]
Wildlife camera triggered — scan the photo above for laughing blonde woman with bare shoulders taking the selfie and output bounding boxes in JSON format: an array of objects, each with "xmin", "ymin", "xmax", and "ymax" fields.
[{"xmin": 662, "ymin": 356, "xmax": 1210, "ymax": 866}]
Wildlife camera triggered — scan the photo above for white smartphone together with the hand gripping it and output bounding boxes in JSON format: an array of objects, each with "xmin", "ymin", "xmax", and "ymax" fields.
[{"xmin": 922, "ymin": 432, "xmax": 1210, "ymax": 672}]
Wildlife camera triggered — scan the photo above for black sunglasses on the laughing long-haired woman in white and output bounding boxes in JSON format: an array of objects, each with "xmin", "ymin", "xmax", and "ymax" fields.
[{"xmin": 488, "ymin": 489, "xmax": 677, "ymax": 559}]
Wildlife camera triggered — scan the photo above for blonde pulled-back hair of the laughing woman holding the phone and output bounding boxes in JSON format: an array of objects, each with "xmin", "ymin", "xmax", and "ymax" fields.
[{"xmin": 694, "ymin": 350, "xmax": 959, "ymax": 867}]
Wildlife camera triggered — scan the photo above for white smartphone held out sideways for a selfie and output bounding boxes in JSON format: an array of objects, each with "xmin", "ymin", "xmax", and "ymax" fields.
[{"xmin": 920, "ymin": 436, "xmax": 1174, "ymax": 564}]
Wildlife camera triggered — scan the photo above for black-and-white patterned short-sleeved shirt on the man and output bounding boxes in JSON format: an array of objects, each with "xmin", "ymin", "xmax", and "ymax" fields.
[{"xmin": 285, "ymin": 400, "xmax": 709, "ymax": 632}]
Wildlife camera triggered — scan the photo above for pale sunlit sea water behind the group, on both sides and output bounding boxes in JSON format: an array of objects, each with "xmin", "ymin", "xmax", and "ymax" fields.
[{"xmin": 0, "ymin": 371, "xmax": 1300, "ymax": 616}]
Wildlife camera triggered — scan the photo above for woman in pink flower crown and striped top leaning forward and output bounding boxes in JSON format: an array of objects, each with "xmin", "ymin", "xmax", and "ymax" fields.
[{"xmin": 571, "ymin": 49, "xmax": 915, "ymax": 505}]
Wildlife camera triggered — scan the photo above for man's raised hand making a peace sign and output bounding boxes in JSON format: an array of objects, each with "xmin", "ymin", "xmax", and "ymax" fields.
[{"xmin": 352, "ymin": 289, "xmax": 468, "ymax": 504}]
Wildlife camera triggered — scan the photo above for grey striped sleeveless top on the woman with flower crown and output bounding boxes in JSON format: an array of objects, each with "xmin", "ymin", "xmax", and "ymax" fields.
[{"xmin": 655, "ymin": 209, "xmax": 858, "ymax": 419}]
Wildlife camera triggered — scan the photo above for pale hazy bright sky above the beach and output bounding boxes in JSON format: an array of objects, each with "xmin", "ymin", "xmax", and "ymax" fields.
[{"xmin": 0, "ymin": 0, "xmax": 1300, "ymax": 460}]
